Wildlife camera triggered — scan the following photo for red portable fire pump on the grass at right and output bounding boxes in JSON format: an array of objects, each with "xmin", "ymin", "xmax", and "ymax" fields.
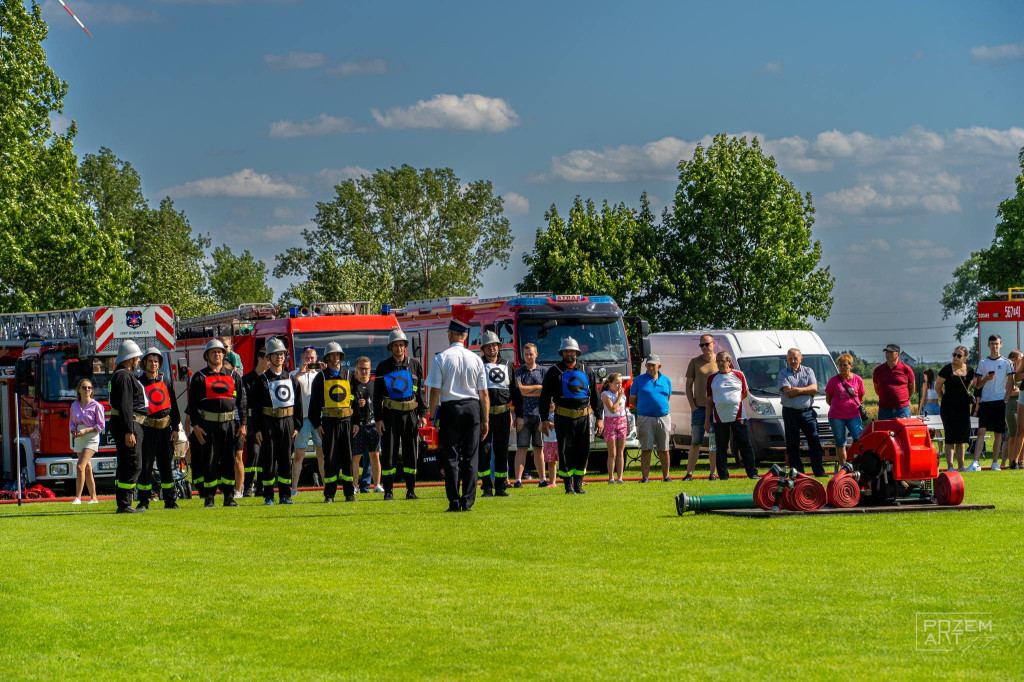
[{"xmin": 827, "ymin": 419, "xmax": 964, "ymax": 507}]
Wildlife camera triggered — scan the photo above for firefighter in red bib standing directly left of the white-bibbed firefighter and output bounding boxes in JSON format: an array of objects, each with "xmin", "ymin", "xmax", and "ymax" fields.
[{"xmin": 188, "ymin": 339, "xmax": 248, "ymax": 507}]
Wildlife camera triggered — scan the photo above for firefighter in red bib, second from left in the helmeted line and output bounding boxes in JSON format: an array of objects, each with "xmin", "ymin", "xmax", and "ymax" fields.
[{"xmin": 138, "ymin": 347, "xmax": 181, "ymax": 509}]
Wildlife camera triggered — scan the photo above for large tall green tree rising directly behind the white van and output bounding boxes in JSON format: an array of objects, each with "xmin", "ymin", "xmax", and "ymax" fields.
[{"xmin": 657, "ymin": 135, "xmax": 835, "ymax": 329}]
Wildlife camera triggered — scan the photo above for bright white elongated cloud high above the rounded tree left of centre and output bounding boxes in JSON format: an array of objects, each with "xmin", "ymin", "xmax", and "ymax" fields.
[{"xmin": 370, "ymin": 94, "xmax": 519, "ymax": 132}]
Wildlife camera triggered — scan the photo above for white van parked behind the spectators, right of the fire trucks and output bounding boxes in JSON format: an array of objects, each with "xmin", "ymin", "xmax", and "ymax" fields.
[{"xmin": 645, "ymin": 330, "xmax": 838, "ymax": 461}]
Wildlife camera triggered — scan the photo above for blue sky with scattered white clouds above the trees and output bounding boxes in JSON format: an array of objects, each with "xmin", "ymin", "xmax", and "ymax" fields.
[{"xmin": 36, "ymin": 0, "xmax": 1024, "ymax": 359}]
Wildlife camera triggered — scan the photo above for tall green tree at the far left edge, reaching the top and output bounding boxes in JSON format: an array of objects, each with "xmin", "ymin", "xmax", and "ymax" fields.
[{"xmin": 0, "ymin": 2, "xmax": 130, "ymax": 311}]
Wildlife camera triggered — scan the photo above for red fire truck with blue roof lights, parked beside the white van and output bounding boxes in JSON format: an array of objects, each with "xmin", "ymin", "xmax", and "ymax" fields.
[{"xmin": 395, "ymin": 292, "xmax": 639, "ymax": 454}]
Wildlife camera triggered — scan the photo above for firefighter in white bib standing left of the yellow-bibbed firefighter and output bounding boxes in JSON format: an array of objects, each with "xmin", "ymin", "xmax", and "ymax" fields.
[{"xmin": 252, "ymin": 339, "xmax": 302, "ymax": 505}]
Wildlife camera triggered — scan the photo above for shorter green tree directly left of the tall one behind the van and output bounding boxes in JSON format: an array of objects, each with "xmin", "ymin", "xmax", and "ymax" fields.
[{"xmin": 516, "ymin": 193, "xmax": 671, "ymax": 325}]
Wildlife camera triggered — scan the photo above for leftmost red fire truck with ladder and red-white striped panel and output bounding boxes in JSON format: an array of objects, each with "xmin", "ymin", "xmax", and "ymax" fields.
[{"xmin": 0, "ymin": 304, "xmax": 175, "ymax": 487}]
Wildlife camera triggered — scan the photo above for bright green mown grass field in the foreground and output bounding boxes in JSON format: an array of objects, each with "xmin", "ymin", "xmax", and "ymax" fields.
[{"xmin": 0, "ymin": 464, "xmax": 1024, "ymax": 680}]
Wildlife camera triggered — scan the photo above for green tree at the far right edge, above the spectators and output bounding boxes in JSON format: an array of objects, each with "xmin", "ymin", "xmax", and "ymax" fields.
[{"xmin": 941, "ymin": 147, "xmax": 1024, "ymax": 339}]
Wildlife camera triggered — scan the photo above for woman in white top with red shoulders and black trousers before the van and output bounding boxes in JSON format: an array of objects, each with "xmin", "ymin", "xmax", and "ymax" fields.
[{"xmin": 705, "ymin": 350, "xmax": 758, "ymax": 480}]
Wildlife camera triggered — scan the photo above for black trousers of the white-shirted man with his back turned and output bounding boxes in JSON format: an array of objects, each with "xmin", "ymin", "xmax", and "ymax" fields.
[{"xmin": 437, "ymin": 400, "xmax": 489, "ymax": 509}]
